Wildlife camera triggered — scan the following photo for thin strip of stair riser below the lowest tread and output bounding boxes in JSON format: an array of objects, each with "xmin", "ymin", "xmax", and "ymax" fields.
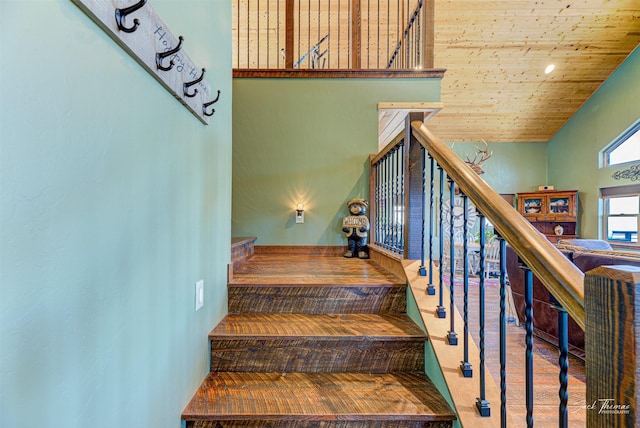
[{"xmin": 186, "ymin": 420, "xmax": 453, "ymax": 428}]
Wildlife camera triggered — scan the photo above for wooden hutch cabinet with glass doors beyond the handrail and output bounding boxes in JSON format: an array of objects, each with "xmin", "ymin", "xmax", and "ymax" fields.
[{"xmin": 518, "ymin": 190, "xmax": 578, "ymax": 242}]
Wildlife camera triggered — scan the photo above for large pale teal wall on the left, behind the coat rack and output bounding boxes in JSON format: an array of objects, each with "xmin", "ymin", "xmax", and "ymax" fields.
[{"xmin": 0, "ymin": 0, "xmax": 232, "ymax": 428}]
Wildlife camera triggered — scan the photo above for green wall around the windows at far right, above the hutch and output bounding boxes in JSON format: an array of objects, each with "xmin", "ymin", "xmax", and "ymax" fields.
[{"xmin": 548, "ymin": 49, "xmax": 640, "ymax": 238}]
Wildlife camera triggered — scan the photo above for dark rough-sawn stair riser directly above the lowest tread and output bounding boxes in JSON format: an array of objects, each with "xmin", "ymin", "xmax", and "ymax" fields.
[{"xmin": 211, "ymin": 338, "xmax": 424, "ymax": 373}]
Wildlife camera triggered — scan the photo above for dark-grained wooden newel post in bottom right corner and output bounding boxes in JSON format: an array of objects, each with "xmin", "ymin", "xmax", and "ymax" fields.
[{"xmin": 584, "ymin": 265, "xmax": 640, "ymax": 428}]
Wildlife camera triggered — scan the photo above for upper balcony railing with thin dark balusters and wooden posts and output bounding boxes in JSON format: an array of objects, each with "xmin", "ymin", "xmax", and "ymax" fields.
[{"xmin": 233, "ymin": 0, "xmax": 433, "ymax": 71}]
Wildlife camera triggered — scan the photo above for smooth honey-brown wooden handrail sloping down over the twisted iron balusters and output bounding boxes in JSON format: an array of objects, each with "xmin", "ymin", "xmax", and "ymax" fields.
[{"xmin": 411, "ymin": 121, "xmax": 586, "ymax": 330}]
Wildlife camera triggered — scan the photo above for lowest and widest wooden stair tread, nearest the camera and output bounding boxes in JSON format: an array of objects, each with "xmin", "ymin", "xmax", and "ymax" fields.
[{"xmin": 182, "ymin": 372, "xmax": 455, "ymax": 421}]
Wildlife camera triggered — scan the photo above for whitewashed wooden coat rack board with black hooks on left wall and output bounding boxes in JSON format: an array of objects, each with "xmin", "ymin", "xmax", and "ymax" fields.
[{"xmin": 72, "ymin": 0, "xmax": 220, "ymax": 125}]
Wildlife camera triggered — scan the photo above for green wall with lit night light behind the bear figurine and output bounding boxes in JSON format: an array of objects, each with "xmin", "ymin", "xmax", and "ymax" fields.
[{"xmin": 232, "ymin": 79, "xmax": 440, "ymax": 245}]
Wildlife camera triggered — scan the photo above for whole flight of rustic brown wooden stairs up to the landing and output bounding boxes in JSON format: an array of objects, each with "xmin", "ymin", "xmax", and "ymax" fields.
[{"xmin": 182, "ymin": 242, "xmax": 455, "ymax": 428}]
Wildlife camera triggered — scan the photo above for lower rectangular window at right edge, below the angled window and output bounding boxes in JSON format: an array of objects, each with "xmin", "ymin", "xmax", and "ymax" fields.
[{"xmin": 601, "ymin": 185, "xmax": 640, "ymax": 244}]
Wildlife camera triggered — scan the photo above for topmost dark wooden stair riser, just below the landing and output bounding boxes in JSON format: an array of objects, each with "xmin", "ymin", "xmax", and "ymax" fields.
[{"xmin": 229, "ymin": 285, "xmax": 407, "ymax": 314}]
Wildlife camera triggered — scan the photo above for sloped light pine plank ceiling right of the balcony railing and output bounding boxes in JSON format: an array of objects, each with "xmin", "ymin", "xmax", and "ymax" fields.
[{"xmin": 428, "ymin": 0, "xmax": 640, "ymax": 142}]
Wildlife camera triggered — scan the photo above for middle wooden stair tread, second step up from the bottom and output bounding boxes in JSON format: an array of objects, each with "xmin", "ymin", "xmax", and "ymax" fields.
[{"xmin": 209, "ymin": 314, "xmax": 426, "ymax": 340}]
